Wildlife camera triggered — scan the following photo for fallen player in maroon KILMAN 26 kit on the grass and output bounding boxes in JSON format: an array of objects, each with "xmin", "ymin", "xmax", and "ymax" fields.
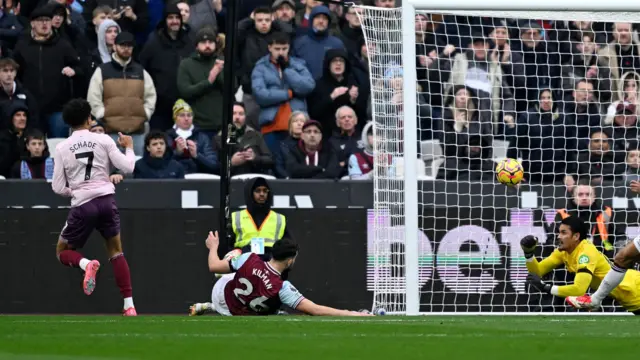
[{"xmin": 197, "ymin": 232, "xmax": 372, "ymax": 316}]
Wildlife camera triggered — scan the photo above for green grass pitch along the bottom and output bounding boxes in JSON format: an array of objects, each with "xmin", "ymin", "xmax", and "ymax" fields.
[{"xmin": 0, "ymin": 316, "xmax": 640, "ymax": 360}]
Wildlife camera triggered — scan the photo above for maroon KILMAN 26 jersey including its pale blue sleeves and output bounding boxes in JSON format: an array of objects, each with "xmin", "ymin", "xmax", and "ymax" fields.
[{"xmin": 224, "ymin": 253, "xmax": 304, "ymax": 316}]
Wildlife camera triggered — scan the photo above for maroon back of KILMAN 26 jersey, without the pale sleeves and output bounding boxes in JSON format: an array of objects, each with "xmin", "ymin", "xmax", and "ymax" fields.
[{"xmin": 224, "ymin": 254, "xmax": 282, "ymax": 315}]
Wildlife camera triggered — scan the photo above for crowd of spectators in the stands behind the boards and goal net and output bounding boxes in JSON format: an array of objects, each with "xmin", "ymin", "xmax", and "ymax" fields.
[{"xmin": 0, "ymin": 0, "xmax": 640, "ymax": 184}]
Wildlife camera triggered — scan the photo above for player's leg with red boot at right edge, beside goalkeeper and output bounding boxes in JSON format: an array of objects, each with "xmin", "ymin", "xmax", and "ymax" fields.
[{"xmin": 566, "ymin": 236, "xmax": 640, "ymax": 310}]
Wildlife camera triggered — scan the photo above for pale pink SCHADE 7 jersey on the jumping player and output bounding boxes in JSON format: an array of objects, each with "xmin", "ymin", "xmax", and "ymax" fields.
[{"xmin": 51, "ymin": 130, "xmax": 136, "ymax": 207}]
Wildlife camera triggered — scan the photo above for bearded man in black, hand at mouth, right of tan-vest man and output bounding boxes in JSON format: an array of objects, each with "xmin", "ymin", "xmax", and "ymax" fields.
[{"xmin": 140, "ymin": 4, "xmax": 195, "ymax": 131}]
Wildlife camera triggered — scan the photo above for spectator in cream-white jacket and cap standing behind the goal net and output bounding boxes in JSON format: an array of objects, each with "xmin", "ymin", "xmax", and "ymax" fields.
[{"xmin": 445, "ymin": 33, "xmax": 516, "ymax": 132}]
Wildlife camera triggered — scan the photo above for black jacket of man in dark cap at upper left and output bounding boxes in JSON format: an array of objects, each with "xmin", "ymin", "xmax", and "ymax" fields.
[{"xmin": 13, "ymin": 34, "xmax": 82, "ymax": 114}]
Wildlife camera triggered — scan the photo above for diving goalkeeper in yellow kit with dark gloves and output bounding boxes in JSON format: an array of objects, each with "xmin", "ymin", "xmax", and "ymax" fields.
[{"xmin": 520, "ymin": 216, "xmax": 640, "ymax": 315}]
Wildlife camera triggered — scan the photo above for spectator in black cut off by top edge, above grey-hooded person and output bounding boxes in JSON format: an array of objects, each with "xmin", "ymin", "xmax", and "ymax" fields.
[{"xmin": 83, "ymin": 0, "xmax": 149, "ymax": 34}]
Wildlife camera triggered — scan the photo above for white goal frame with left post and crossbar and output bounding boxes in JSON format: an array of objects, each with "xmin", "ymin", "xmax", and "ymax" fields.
[{"xmin": 392, "ymin": 0, "xmax": 640, "ymax": 316}]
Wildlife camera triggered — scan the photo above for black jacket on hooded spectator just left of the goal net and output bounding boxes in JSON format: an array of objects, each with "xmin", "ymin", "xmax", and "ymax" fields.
[{"xmin": 307, "ymin": 49, "xmax": 368, "ymax": 138}]
